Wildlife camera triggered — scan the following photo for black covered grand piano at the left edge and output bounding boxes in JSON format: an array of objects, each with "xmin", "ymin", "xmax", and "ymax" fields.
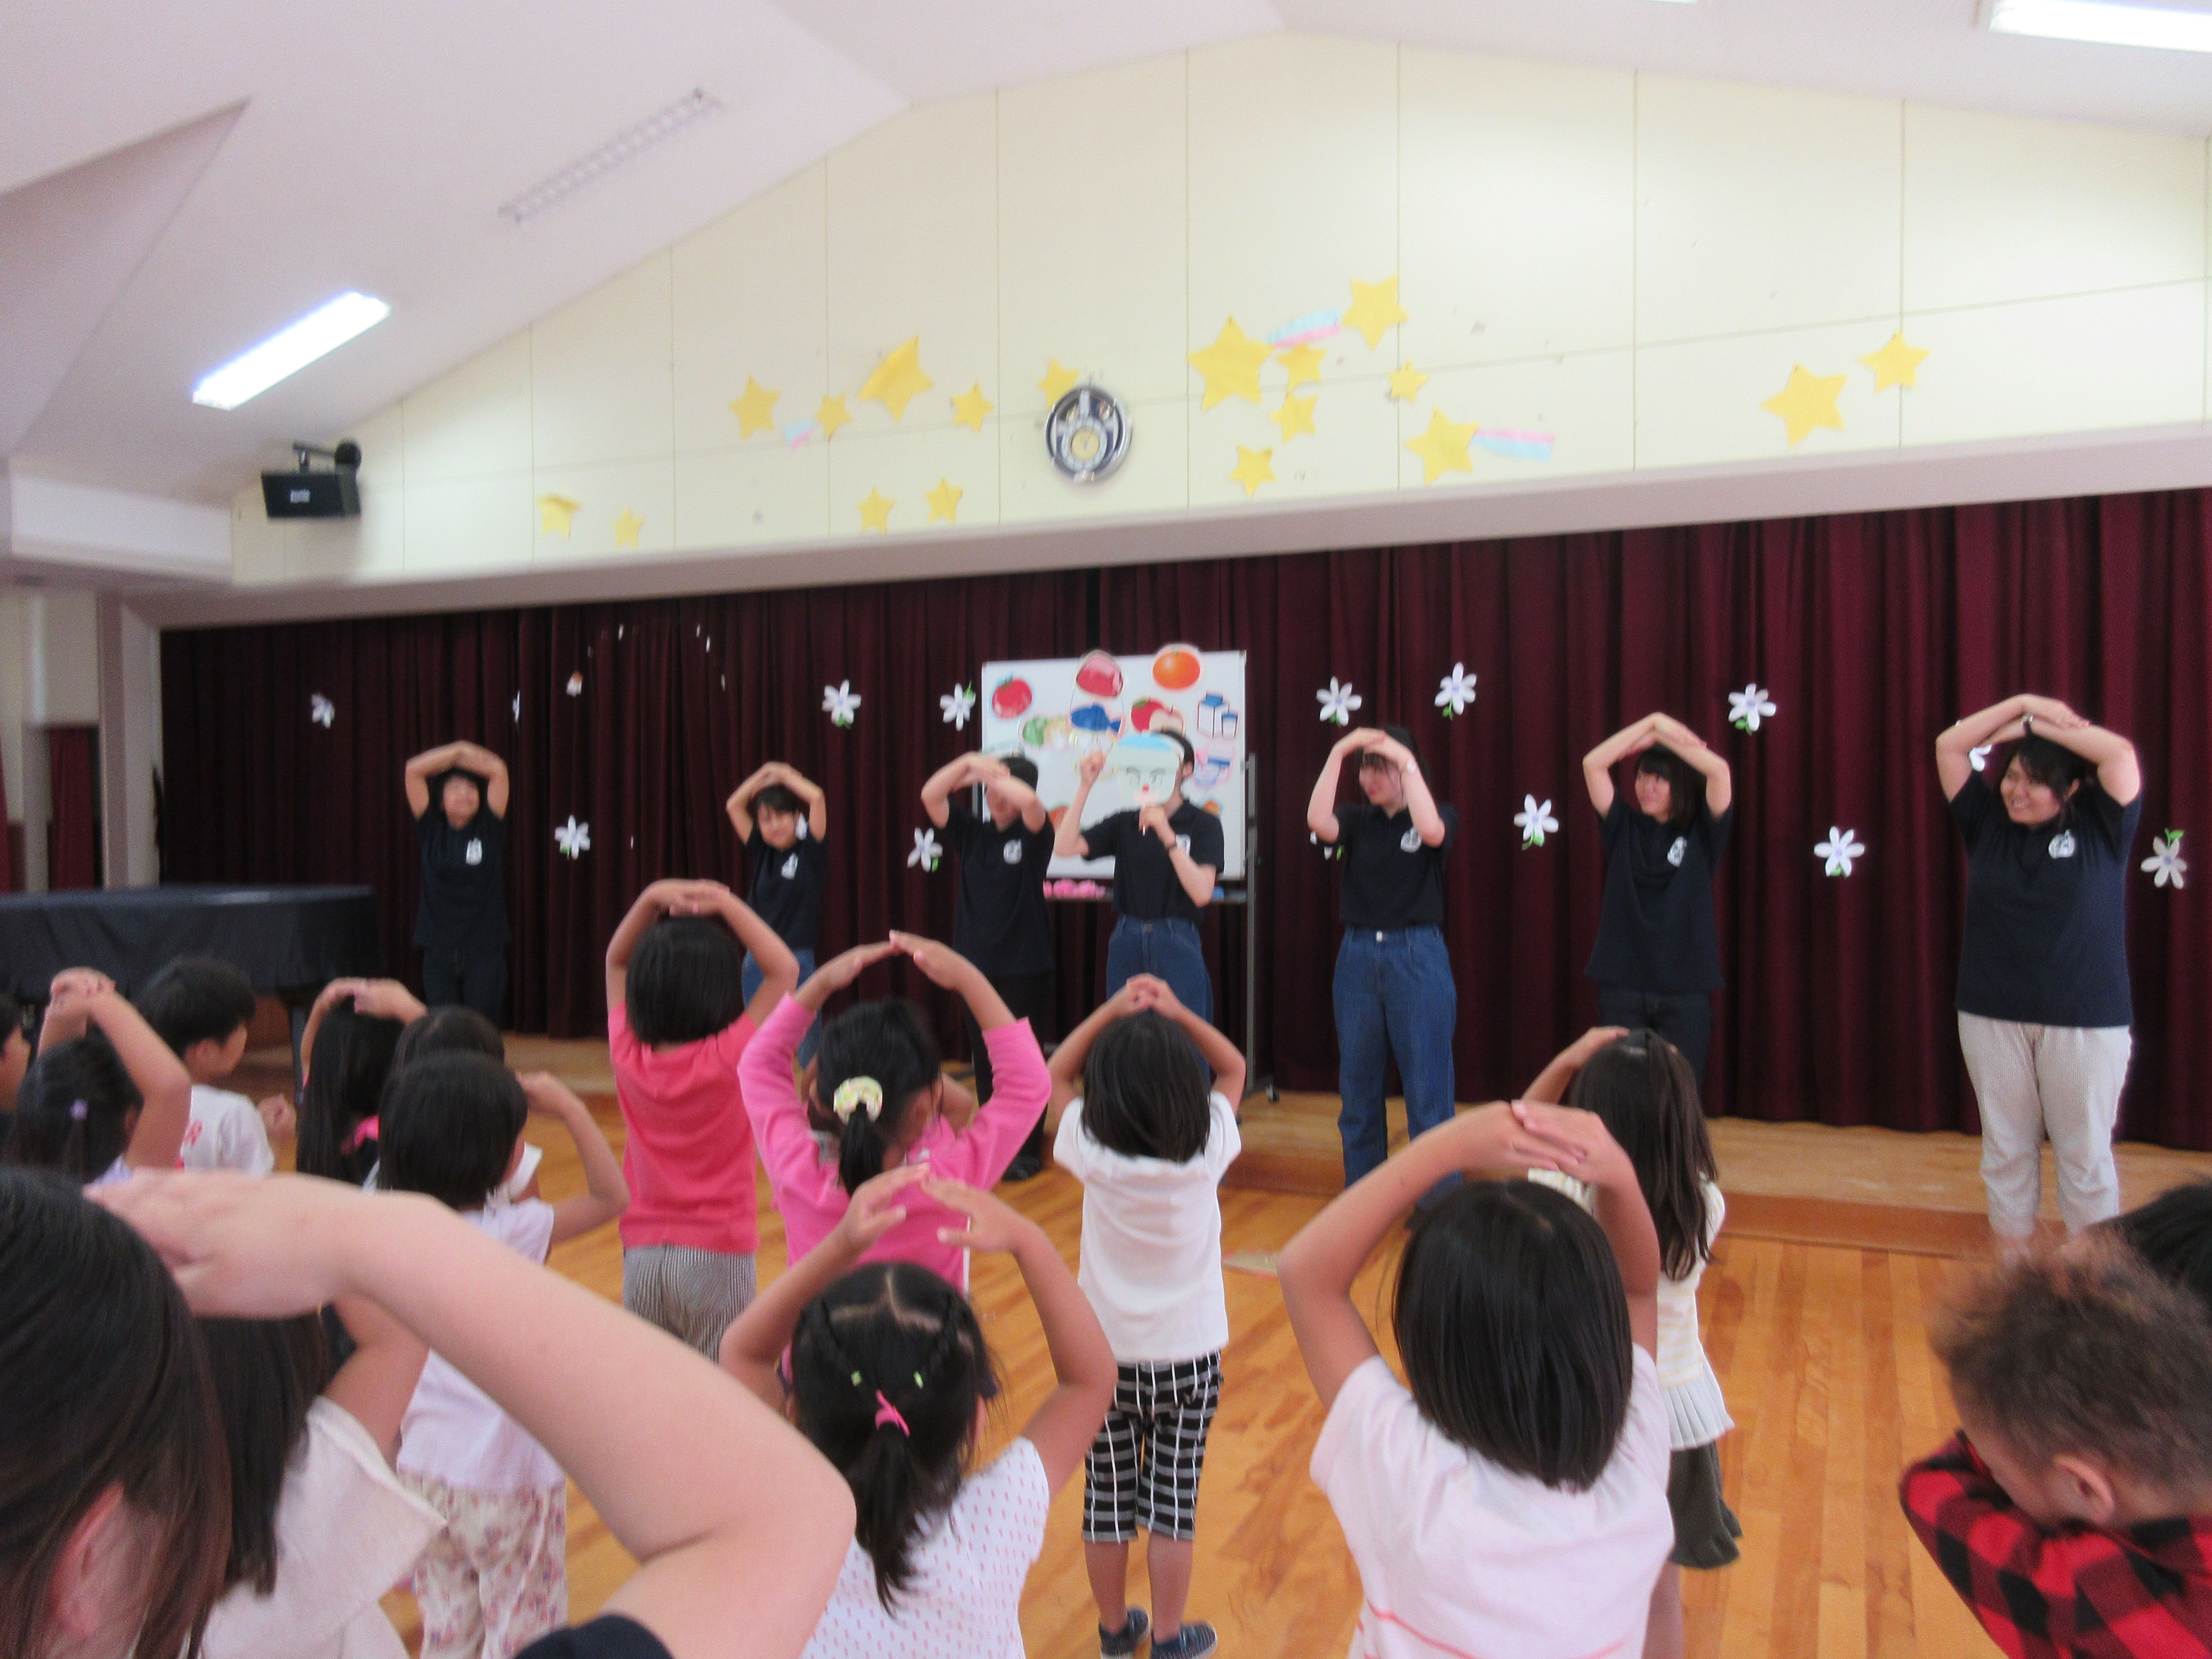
[{"xmin": 0, "ymin": 882, "xmax": 385, "ymax": 1044}]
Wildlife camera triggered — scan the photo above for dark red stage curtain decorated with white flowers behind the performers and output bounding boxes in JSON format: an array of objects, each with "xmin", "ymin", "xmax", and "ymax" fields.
[{"xmin": 161, "ymin": 493, "xmax": 2212, "ymax": 1148}]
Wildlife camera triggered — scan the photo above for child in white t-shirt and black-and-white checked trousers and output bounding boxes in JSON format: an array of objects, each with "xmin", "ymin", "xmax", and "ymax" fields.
[{"xmin": 1051, "ymin": 973, "xmax": 1246, "ymax": 1659}]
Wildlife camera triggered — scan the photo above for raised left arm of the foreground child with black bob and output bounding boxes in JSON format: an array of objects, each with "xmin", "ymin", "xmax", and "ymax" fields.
[{"xmin": 1276, "ymin": 1104, "xmax": 1557, "ymax": 1409}]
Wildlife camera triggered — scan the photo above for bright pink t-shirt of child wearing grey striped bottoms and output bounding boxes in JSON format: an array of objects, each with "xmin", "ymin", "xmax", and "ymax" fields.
[{"xmin": 606, "ymin": 1002, "xmax": 765, "ymax": 1257}]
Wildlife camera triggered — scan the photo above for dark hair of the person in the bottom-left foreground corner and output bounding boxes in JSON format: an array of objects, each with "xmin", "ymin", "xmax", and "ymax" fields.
[{"xmin": 0, "ymin": 1168, "xmax": 230, "ymax": 1659}]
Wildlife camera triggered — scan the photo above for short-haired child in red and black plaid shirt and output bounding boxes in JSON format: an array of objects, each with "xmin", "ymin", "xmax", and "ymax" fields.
[{"xmin": 1900, "ymin": 1237, "xmax": 2212, "ymax": 1659}]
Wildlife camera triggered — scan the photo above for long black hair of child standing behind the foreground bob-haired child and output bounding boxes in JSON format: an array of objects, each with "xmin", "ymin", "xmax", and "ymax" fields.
[{"xmin": 1566, "ymin": 1031, "xmax": 1721, "ymax": 1278}]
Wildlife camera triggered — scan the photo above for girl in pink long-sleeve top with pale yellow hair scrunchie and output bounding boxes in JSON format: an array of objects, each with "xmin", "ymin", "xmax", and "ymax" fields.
[{"xmin": 736, "ymin": 934, "xmax": 1053, "ymax": 1289}]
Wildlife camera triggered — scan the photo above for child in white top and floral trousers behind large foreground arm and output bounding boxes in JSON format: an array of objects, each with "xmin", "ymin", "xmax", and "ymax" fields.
[{"xmin": 376, "ymin": 1053, "xmax": 630, "ymax": 1659}]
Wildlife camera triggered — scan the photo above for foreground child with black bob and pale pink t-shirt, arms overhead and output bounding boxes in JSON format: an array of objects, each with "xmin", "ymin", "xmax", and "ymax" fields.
[{"xmin": 1278, "ymin": 1102, "xmax": 1674, "ymax": 1659}]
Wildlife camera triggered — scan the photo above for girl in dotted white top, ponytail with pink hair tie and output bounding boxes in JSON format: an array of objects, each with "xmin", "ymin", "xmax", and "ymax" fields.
[{"xmin": 721, "ymin": 1164, "xmax": 1115, "ymax": 1659}]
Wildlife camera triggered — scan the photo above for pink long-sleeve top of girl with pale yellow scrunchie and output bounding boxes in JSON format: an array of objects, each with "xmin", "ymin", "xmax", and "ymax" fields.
[{"xmin": 736, "ymin": 998, "xmax": 1053, "ymax": 1289}]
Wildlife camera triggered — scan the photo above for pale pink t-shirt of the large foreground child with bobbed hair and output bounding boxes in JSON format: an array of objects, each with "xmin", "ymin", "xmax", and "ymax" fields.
[{"xmin": 1312, "ymin": 1347, "xmax": 1674, "ymax": 1659}]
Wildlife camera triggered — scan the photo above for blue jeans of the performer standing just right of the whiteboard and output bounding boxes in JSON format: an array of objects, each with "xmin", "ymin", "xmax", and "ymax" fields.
[{"xmin": 1336, "ymin": 927, "xmax": 1460, "ymax": 1186}]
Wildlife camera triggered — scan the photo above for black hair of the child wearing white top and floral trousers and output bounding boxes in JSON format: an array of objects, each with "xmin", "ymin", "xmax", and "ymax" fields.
[{"xmin": 376, "ymin": 1053, "xmax": 531, "ymax": 1210}]
